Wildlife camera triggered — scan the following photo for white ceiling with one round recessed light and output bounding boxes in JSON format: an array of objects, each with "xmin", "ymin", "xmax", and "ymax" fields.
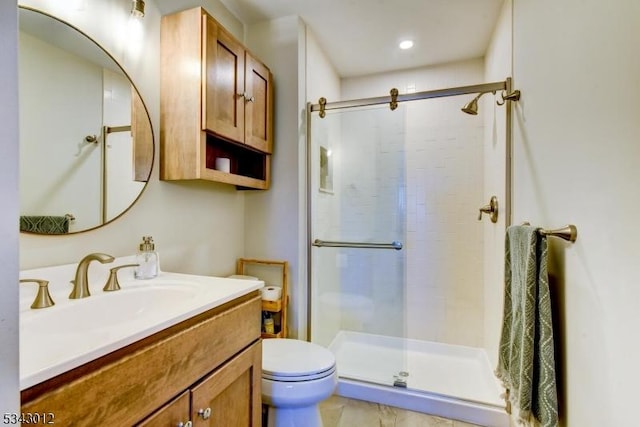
[{"xmin": 215, "ymin": 0, "xmax": 503, "ymax": 77}]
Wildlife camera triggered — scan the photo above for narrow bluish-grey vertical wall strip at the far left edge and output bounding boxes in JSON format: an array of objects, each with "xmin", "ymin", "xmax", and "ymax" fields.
[{"xmin": 0, "ymin": 1, "xmax": 20, "ymax": 413}]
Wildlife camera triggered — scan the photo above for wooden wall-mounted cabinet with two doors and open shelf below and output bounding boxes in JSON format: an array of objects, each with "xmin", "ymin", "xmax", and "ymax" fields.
[{"xmin": 160, "ymin": 7, "xmax": 273, "ymax": 189}]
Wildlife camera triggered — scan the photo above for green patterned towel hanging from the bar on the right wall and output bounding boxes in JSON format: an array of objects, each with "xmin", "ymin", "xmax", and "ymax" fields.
[{"xmin": 496, "ymin": 225, "xmax": 558, "ymax": 427}]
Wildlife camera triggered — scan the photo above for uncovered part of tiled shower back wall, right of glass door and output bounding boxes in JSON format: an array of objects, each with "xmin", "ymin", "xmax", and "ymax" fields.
[{"xmin": 405, "ymin": 97, "xmax": 487, "ymax": 347}]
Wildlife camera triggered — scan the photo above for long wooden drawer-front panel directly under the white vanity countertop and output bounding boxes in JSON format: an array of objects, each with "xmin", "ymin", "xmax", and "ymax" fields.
[{"xmin": 22, "ymin": 291, "xmax": 261, "ymax": 427}]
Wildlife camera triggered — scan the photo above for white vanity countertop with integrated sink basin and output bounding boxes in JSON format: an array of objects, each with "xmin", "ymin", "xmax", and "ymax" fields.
[{"xmin": 20, "ymin": 257, "xmax": 264, "ymax": 389}]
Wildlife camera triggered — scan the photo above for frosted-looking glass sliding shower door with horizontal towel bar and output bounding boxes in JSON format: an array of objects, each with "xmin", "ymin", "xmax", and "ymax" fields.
[{"xmin": 310, "ymin": 105, "xmax": 406, "ymax": 386}]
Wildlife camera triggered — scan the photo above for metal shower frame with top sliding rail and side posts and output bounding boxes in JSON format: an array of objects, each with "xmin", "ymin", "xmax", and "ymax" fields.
[{"xmin": 306, "ymin": 77, "xmax": 520, "ymax": 341}]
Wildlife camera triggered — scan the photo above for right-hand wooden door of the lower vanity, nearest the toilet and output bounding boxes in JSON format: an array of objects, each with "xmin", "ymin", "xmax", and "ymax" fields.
[{"xmin": 191, "ymin": 341, "xmax": 262, "ymax": 427}]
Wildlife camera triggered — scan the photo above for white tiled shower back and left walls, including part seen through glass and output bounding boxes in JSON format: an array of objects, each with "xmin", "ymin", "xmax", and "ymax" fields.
[{"xmin": 312, "ymin": 93, "xmax": 485, "ymax": 346}]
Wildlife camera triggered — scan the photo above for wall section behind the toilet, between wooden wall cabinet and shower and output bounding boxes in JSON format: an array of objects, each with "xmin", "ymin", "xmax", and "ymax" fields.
[{"xmin": 244, "ymin": 16, "xmax": 306, "ymax": 337}]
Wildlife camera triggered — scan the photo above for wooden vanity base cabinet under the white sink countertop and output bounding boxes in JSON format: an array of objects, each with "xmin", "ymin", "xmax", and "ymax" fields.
[{"xmin": 21, "ymin": 291, "xmax": 262, "ymax": 427}]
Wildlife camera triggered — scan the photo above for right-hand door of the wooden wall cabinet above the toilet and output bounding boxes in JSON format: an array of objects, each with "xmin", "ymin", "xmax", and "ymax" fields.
[{"xmin": 245, "ymin": 52, "xmax": 273, "ymax": 153}]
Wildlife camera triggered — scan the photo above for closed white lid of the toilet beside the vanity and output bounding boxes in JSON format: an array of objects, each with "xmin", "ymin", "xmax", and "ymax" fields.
[{"xmin": 262, "ymin": 338, "xmax": 336, "ymax": 379}]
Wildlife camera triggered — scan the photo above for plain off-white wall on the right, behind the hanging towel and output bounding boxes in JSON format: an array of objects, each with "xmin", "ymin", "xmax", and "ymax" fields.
[{"xmin": 513, "ymin": 0, "xmax": 640, "ymax": 427}]
